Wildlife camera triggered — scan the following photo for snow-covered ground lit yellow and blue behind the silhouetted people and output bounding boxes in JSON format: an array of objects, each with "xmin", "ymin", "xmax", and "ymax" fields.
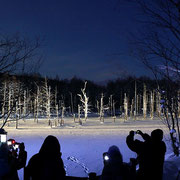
[{"xmin": 1, "ymin": 118, "xmax": 180, "ymax": 180}]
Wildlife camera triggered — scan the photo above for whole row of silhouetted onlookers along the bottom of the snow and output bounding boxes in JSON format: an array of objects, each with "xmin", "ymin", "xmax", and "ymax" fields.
[{"xmin": 0, "ymin": 129, "xmax": 166, "ymax": 180}]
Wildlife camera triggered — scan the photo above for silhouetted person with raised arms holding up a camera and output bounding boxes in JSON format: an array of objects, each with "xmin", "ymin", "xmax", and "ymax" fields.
[{"xmin": 126, "ymin": 129, "xmax": 166, "ymax": 180}]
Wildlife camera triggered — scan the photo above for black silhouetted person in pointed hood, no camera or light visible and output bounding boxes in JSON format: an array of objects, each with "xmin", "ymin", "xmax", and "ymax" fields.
[{"xmin": 25, "ymin": 135, "xmax": 65, "ymax": 180}]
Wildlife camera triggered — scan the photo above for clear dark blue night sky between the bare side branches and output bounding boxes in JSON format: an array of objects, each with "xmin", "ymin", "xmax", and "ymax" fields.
[{"xmin": 0, "ymin": 0, "xmax": 152, "ymax": 81}]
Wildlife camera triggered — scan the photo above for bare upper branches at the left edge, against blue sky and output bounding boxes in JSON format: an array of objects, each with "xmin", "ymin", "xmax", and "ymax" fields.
[{"xmin": 0, "ymin": 34, "xmax": 40, "ymax": 73}]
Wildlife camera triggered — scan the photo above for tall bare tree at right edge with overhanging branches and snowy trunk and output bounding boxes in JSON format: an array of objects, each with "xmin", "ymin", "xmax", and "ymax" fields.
[{"xmin": 124, "ymin": 0, "xmax": 180, "ymax": 155}]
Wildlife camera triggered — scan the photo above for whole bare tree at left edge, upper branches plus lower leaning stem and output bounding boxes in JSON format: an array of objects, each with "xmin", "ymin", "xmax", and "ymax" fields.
[{"xmin": 0, "ymin": 34, "xmax": 41, "ymax": 127}]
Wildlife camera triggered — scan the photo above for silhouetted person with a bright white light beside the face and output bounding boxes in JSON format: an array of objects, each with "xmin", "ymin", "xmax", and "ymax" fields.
[{"xmin": 101, "ymin": 146, "xmax": 133, "ymax": 180}]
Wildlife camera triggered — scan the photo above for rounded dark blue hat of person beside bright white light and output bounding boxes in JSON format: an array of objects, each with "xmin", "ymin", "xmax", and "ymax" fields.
[{"xmin": 108, "ymin": 145, "xmax": 123, "ymax": 162}]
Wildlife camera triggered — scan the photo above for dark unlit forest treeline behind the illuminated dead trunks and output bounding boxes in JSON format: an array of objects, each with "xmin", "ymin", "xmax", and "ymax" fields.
[{"xmin": 0, "ymin": 74, "xmax": 165, "ymax": 112}]
